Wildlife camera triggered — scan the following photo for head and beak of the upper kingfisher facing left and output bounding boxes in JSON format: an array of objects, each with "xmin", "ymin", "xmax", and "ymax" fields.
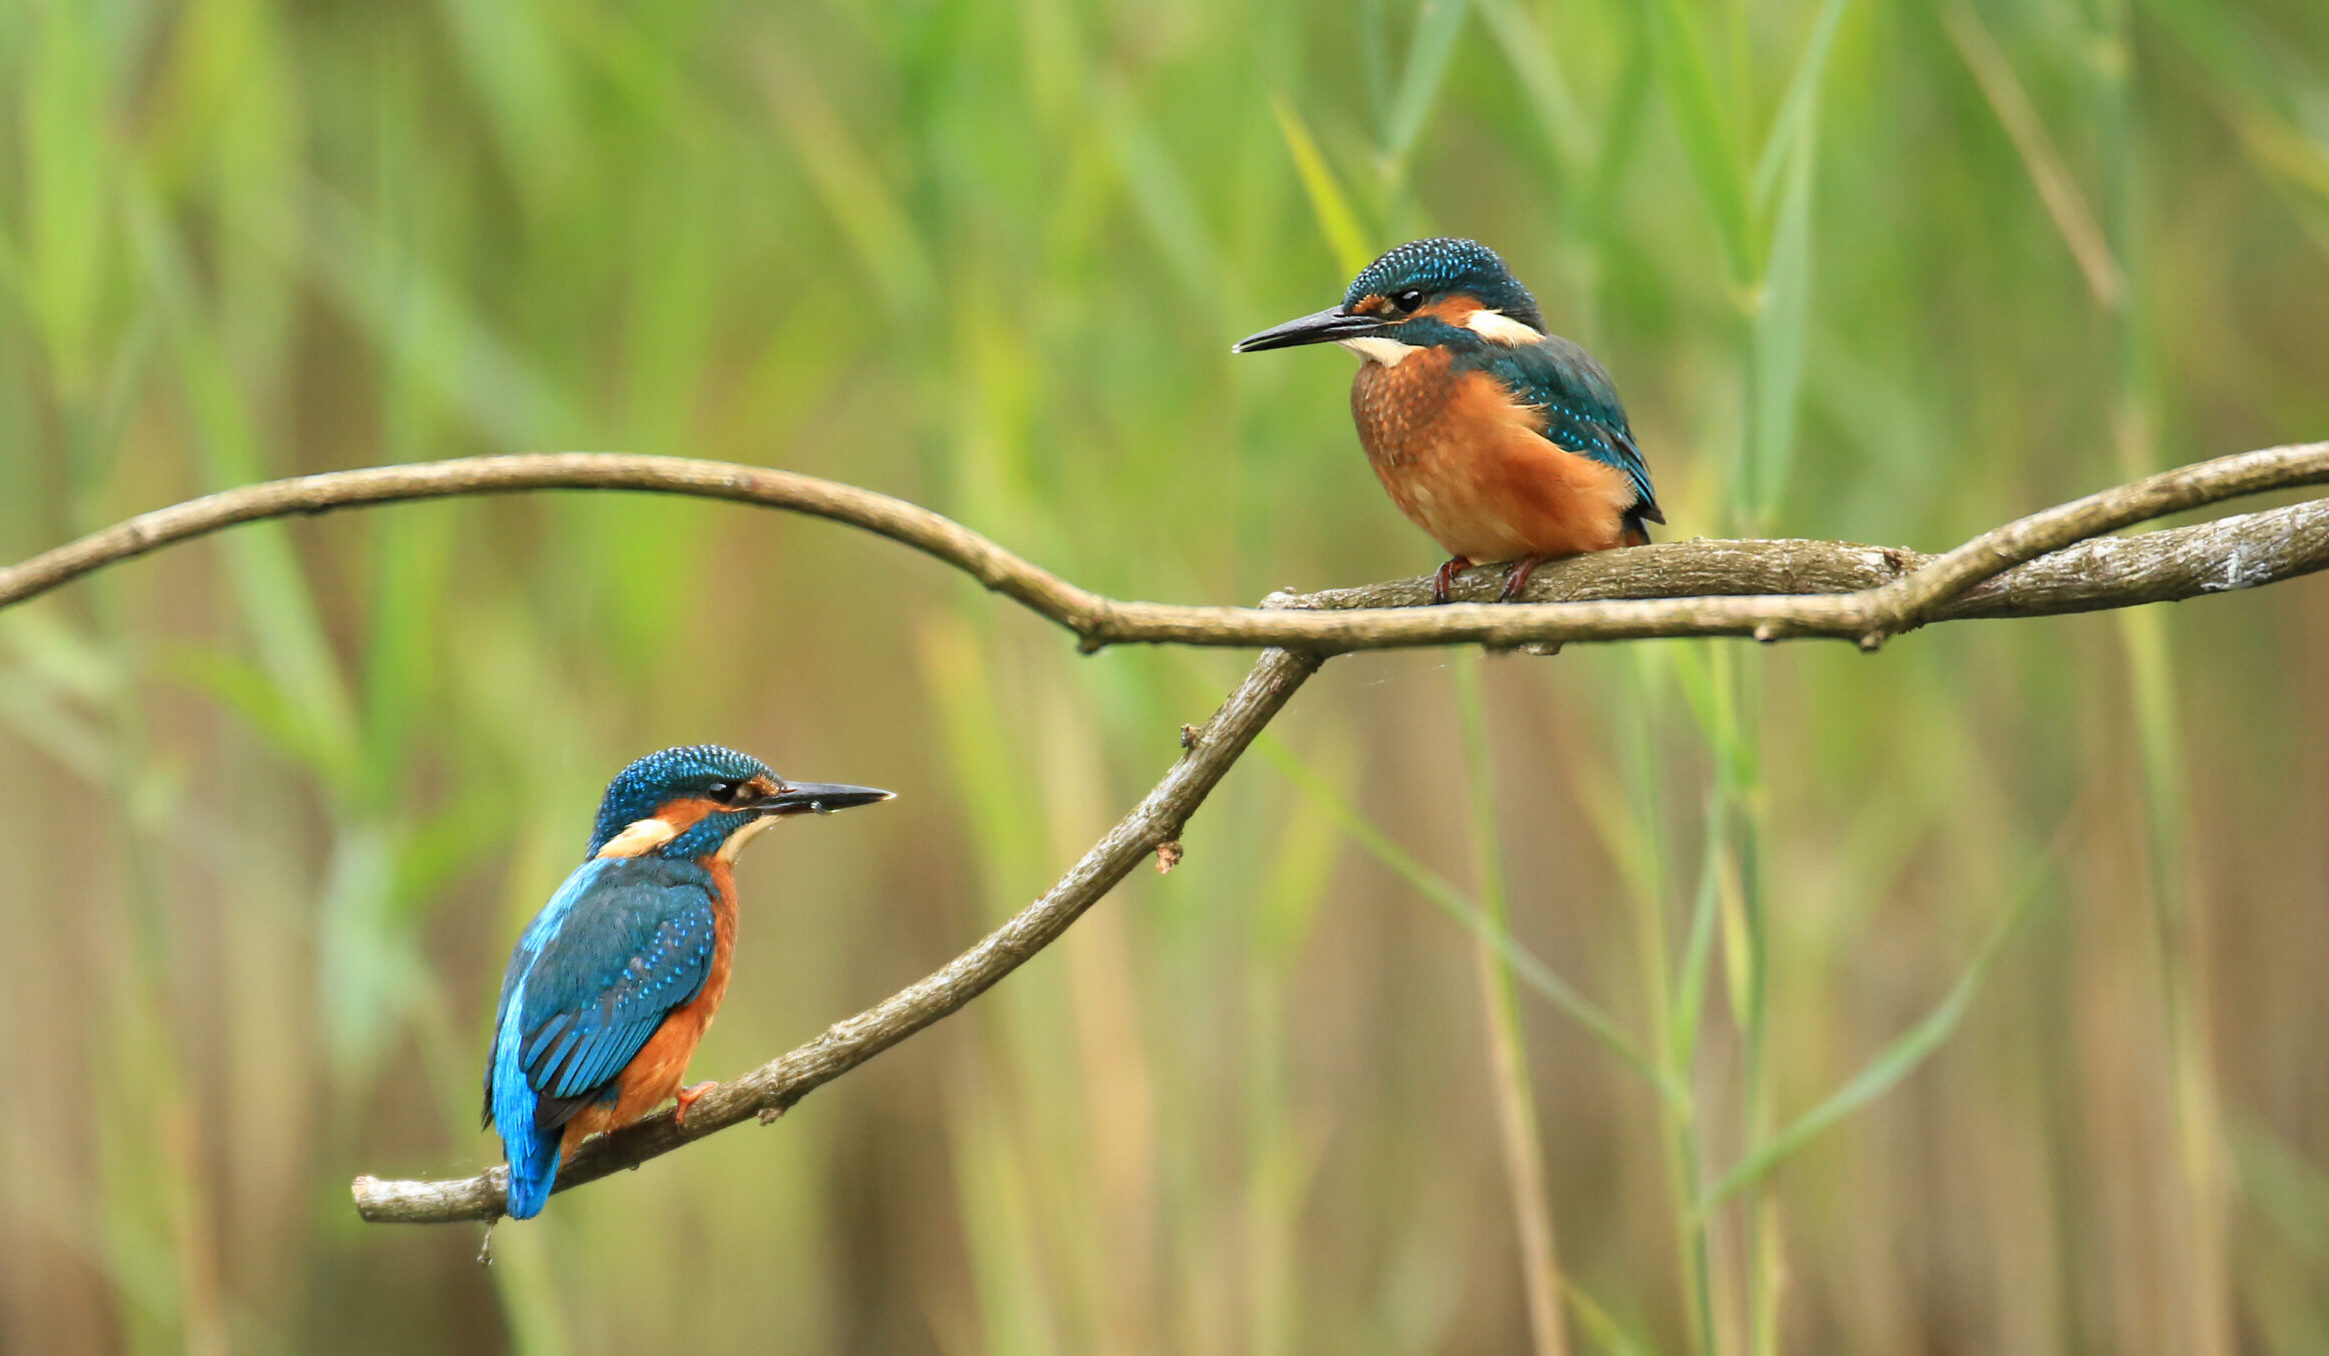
[{"xmin": 1234, "ymin": 238, "xmax": 1544, "ymax": 366}]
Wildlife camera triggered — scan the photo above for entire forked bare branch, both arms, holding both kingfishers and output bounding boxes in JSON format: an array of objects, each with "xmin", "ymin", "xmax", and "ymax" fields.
[{"xmin": 0, "ymin": 443, "xmax": 2329, "ymax": 1223}]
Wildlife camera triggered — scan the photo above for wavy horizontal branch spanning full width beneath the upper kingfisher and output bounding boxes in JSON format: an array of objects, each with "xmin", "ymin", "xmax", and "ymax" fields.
[{"xmin": 13, "ymin": 443, "xmax": 2329, "ymax": 655}]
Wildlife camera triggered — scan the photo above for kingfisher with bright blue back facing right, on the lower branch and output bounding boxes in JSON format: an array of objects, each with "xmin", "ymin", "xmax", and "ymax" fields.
[{"xmin": 484, "ymin": 743, "xmax": 892, "ymax": 1219}]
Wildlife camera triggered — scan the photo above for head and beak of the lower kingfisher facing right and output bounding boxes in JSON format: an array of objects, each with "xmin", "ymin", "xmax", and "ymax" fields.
[{"xmin": 585, "ymin": 743, "xmax": 894, "ymax": 862}]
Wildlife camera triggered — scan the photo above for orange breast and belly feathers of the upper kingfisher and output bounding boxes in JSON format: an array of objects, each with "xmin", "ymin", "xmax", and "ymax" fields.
[{"xmin": 1351, "ymin": 358, "xmax": 1633, "ymax": 562}]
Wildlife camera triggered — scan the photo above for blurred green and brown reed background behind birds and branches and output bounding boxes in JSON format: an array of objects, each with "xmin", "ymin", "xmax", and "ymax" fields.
[{"xmin": 0, "ymin": 0, "xmax": 2329, "ymax": 1356}]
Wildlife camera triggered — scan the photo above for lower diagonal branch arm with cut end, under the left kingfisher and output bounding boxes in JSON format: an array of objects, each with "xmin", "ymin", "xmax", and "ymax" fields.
[{"xmin": 352, "ymin": 650, "xmax": 1321, "ymax": 1223}]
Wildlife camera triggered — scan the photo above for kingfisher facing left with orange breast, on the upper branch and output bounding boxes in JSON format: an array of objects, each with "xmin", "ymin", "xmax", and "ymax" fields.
[{"xmin": 1234, "ymin": 238, "xmax": 1665, "ymax": 603}]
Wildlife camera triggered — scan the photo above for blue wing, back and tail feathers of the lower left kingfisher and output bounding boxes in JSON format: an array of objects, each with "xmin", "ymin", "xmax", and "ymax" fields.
[{"xmin": 484, "ymin": 857, "xmax": 717, "ymax": 1219}]
